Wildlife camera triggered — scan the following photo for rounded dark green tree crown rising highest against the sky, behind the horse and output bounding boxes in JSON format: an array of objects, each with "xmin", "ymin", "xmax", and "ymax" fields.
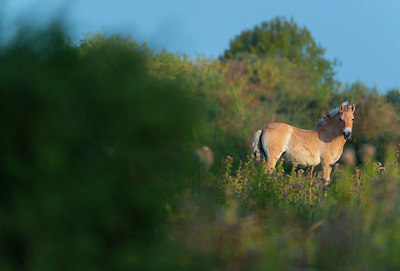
[{"xmin": 222, "ymin": 17, "xmax": 336, "ymax": 86}]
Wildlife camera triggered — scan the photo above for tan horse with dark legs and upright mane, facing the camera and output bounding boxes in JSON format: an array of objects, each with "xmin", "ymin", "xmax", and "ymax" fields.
[{"xmin": 253, "ymin": 102, "xmax": 356, "ymax": 183}]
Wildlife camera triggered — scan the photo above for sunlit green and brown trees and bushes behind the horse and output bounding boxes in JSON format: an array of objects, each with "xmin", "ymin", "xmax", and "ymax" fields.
[{"xmin": 136, "ymin": 17, "xmax": 400, "ymax": 166}]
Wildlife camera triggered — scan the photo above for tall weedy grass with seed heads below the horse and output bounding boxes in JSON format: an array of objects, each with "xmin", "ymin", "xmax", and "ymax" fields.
[{"xmin": 170, "ymin": 150, "xmax": 400, "ymax": 270}]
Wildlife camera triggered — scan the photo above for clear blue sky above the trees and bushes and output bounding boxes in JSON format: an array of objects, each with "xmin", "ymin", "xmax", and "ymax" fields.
[{"xmin": 3, "ymin": 0, "xmax": 400, "ymax": 91}]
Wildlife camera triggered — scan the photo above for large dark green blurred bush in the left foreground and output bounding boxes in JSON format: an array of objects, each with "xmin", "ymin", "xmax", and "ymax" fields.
[{"xmin": 0, "ymin": 24, "xmax": 198, "ymax": 270}]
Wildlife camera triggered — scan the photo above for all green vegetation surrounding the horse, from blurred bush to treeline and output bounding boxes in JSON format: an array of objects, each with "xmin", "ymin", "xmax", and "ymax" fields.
[{"xmin": 0, "ymin": 18, "xmax": 400, "ymax": 271}]
